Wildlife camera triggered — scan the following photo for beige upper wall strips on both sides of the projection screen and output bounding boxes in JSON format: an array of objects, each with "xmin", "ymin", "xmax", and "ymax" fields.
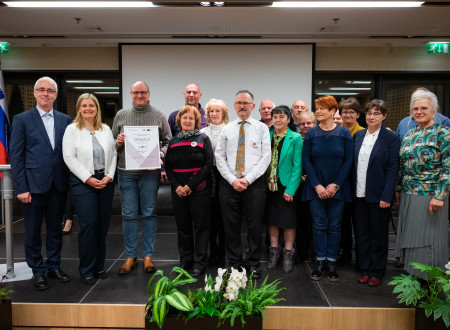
[{"xmin": 0, "ymin": 45, "xmax": 450, "ymax": 71}]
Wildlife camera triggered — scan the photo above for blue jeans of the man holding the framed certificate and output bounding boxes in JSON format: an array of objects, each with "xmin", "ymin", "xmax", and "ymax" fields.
[{"xmin": 118, "ymin": 170, "xmax": 161, "ymax": 258}]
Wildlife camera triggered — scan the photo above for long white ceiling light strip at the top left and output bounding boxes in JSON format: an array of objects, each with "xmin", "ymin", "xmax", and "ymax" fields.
[{"xmin": 3, "ymin": 1, "xmax": 155, "ymax": 8}]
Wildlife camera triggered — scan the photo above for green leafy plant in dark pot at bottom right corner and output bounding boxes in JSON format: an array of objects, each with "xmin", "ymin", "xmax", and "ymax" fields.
[{"xmin": 388, "ymin": 262, "xmax": 450, "ymax": 329}]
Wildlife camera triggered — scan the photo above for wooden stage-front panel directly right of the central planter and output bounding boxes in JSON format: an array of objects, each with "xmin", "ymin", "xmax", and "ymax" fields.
[{"xmin": 263, "ymin": 307, "xmax": 332, "ymax": 330}]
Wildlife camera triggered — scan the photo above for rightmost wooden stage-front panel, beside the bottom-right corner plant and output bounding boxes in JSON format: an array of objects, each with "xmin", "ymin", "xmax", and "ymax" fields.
[{"xmin": 332, "ymin": 307, "xmax": 415, "ymax": 330}]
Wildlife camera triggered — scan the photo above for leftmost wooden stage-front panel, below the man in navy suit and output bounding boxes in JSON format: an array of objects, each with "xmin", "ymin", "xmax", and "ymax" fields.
[{"xmin": 12, "ymin": 303, "xmax": 78, "ymax": 327}]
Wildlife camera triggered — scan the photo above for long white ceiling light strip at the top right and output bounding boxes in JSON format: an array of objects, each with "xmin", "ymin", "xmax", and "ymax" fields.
[{"xmin": 272, "ymin": 1, "xmax": 424, "ymax": 8}]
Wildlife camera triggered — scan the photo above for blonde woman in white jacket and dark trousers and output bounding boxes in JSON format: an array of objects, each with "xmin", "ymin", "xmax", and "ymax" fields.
[{"xmin": 63, "ymin": 93, "xmax": 117, "ymax": 285}]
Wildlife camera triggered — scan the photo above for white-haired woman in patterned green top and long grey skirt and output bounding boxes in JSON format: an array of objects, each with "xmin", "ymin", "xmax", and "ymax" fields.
[{"xmin": 396, "ymin": 92, "xmax": 450, "ymax": 279}]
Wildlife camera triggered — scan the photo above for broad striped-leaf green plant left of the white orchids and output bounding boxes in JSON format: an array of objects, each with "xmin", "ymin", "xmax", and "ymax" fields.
[{"xmin": 145, "ymin": 267, "xmax": 197, "ymax": 328}]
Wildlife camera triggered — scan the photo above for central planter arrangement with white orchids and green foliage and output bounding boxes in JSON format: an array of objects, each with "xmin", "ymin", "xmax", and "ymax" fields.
[{"xmin": 146, "ymin": 267, "xmax": 283, "ymax": 330}]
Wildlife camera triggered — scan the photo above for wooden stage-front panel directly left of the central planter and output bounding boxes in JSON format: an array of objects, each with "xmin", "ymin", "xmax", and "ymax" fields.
[{"xmin": 79, "ymin": 304, "xmax": 145, "ymax": 328}]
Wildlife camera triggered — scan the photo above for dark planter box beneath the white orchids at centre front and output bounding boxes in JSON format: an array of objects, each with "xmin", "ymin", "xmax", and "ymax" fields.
[{"xmin": 145, "ymin": 316, "xmax": 262, "ymax": 330}]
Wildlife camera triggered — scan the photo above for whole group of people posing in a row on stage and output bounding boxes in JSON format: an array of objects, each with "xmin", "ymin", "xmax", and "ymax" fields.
[{"xmin": 10, "ymin": 77, "xmax": 450, "ymax": 290}]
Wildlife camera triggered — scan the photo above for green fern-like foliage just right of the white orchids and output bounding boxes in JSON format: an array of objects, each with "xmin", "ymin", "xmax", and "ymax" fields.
[{"xmin": 219, "ymin": 276, "xmax": 284, "ymax": 326}]
